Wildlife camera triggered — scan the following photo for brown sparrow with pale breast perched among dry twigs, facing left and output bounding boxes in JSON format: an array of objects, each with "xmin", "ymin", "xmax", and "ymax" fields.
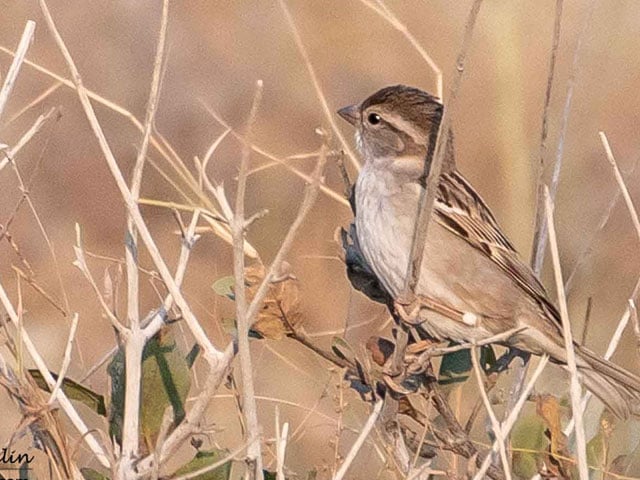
[{"xmin": 338, "ymin": 85, "xmax": 640, "ymax": 418}]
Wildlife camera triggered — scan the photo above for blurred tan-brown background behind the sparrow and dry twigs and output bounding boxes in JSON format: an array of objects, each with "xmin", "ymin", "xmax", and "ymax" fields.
[{"xmin": 0, "ymin": 0, "xmax": 640, "ymax": 478}]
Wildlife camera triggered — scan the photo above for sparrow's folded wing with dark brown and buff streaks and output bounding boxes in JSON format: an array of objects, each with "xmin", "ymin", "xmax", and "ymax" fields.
[{"xmin": 434, "ymin": 171, "xmax": 560, "ymax": 325}]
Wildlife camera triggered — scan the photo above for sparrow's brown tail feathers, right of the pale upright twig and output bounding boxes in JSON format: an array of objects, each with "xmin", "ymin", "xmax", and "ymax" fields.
[{"xmin": 576, "ymin": 345, "xmax": 640, "ymax": 418}]
